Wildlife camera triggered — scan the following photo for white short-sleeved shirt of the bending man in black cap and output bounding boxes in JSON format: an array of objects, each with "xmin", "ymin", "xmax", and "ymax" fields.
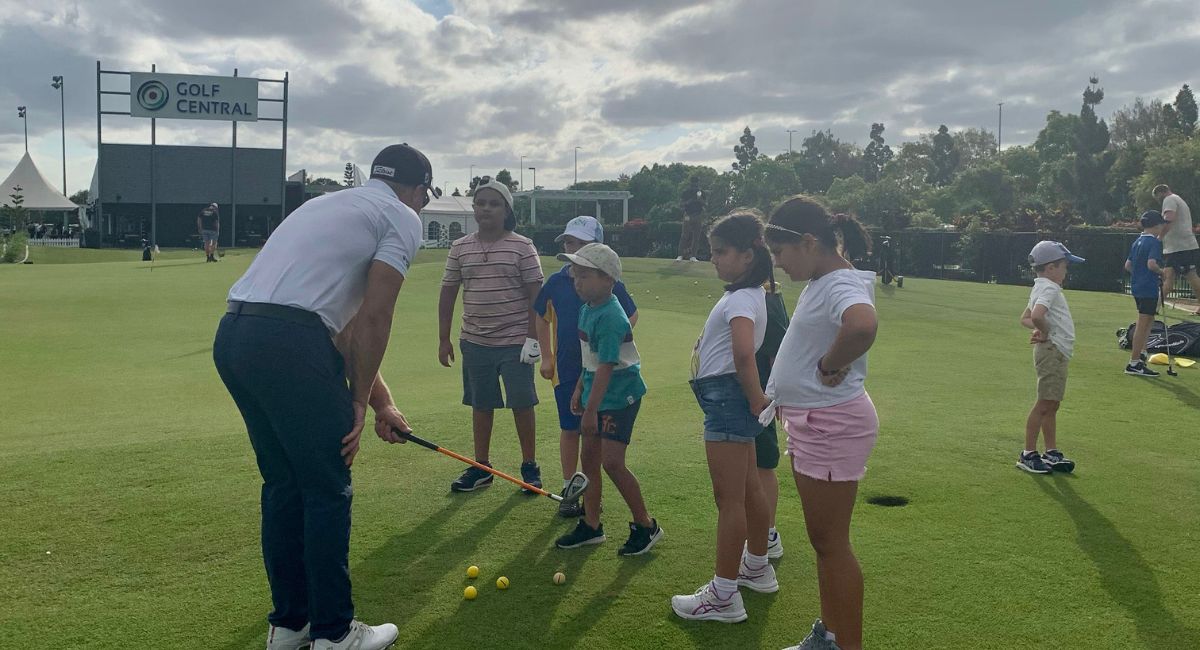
[{"xmin": 229, "ymin": 179, "xmax": 422, "ymax": 335}]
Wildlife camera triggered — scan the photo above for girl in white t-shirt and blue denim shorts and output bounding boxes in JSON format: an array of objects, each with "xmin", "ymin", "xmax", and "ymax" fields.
[{"xmin": 671, "ymin": 210, "xmax": 779, "ymax": 622}]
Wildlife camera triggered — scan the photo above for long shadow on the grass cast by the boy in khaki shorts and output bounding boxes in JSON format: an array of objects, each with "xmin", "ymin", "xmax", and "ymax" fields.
[{"xmin": 1034, "ymin": 475, "xmax": 1200, "ymax": 648}]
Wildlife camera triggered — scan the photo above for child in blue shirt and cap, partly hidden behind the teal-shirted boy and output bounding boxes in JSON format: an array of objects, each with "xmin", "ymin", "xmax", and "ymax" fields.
[{"xmin": 533, "ymin": 217, "xmax": 637, "ymax": 517}]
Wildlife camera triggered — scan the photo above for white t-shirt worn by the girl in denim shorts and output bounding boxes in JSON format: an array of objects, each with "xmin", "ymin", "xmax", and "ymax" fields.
[{"xmin": 691, "ymin": 287, "xmax": 767, "ymax": 379}]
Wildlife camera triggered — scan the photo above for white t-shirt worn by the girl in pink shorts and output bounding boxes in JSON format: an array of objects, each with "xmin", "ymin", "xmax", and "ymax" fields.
[{"xmin": 767, "ymin": 269, "xmax": 875, "ymax": 409}]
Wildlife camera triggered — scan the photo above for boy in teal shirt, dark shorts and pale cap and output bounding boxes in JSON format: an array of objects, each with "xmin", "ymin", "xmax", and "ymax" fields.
[{"xmin": 554, "ymin": 243, "xmax": 662, "ymax": 555}]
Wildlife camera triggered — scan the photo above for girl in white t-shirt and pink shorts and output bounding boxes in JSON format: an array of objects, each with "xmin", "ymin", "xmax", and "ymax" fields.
[{"xmin": 766, "ymin": 197, "xmax": 880, "ymax": 650}]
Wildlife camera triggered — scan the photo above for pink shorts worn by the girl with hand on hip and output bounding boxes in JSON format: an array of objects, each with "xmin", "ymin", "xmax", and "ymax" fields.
[{"xmin": 779, "ymin": 392, "xmax": 880, "ymax": 481}]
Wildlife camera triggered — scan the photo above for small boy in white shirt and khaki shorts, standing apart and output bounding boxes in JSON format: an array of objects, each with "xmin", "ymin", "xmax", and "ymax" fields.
[{"xmin": 1016, "ymin": 241, "xmax": 1084, "ymax": 474}]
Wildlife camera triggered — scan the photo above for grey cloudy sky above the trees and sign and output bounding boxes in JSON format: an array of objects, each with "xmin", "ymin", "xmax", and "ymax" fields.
[{"xmin": 0, "ymin": 0, "xmax": 1200, "ymax": 192}]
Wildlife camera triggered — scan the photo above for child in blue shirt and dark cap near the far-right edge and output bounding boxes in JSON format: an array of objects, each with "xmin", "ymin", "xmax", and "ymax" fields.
[{"xmin": 1126, "ymin": 210, "xmax": 1168, "ymax": 377}]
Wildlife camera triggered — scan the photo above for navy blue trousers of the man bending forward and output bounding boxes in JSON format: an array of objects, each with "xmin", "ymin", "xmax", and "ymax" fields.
[{"xmin": 212, "ymin": 314, "xmax": 354, "ymax": 639}]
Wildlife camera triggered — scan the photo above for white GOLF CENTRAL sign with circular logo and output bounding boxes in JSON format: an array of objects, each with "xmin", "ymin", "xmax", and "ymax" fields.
[{"xmin": 130, "ymin": 72, "xmax": 258, "ymax": 122}]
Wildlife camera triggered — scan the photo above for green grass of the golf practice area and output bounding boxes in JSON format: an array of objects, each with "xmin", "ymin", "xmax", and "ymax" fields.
[{"xmin": 0, "ymin": 251, "xmax": 1200, "ymax": 649}]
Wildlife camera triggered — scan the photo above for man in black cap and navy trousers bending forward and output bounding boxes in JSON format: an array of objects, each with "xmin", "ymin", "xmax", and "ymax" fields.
[{"xmin": 212, "ymin": 144, "xmax": 433, "ymax": 650}]
